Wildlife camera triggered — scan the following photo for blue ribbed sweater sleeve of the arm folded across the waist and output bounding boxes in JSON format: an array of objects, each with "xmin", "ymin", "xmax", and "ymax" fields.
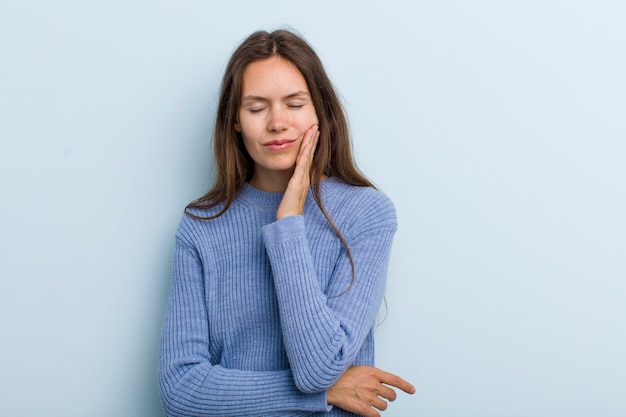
[{"xmin": 159, "ymin": 239, "xmax": 330, "ymax": 417}]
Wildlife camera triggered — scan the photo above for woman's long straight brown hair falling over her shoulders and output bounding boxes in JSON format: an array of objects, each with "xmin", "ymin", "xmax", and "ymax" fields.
[{"xmin": 186, "ymin": 30, "xmax": 374, "ymax": 290}]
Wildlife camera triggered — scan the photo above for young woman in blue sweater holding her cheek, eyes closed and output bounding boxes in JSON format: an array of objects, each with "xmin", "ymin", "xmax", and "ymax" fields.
[{"xmin": 159, "ymin": 30, "xmax": 414, "ymax": 416}]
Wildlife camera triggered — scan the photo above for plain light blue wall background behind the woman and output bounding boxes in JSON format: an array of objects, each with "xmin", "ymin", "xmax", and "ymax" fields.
[{"xmin": 0, "ymin": 0, "xmax": 626, "ymax": 417}]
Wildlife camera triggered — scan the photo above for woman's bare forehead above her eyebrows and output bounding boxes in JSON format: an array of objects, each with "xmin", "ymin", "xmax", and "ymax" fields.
[{"xmin": 241, "ymin": 56, "xmax": 309, "ymax": 98}]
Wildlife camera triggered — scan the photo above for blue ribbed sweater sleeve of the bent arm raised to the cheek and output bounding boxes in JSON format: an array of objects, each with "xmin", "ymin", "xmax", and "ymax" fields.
[{"xmin": 263, "ymin": 193, "xmax": 397, "ymax": 393}]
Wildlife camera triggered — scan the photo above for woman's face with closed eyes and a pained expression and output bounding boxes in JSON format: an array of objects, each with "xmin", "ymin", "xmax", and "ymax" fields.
[{"xmin": 235, "ymin": 56, "xmax": 318, "ymax": 187}]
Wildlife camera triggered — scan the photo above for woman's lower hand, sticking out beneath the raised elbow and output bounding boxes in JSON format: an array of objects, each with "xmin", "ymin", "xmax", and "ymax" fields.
[{"xmin": 326, "ymin": 366, "xmax": 415, "ymax": 417}]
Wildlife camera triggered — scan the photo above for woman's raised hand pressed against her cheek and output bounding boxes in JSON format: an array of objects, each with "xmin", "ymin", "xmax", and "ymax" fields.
[{"xmin": 276, "ymin": 125, "xmax": 320, "ymax": 219}]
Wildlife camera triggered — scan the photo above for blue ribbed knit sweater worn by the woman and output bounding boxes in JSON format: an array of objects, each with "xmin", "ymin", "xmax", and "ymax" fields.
[{"xmin": 159, "ymin": 178, "xmax": 396, "ymax": 417}]
